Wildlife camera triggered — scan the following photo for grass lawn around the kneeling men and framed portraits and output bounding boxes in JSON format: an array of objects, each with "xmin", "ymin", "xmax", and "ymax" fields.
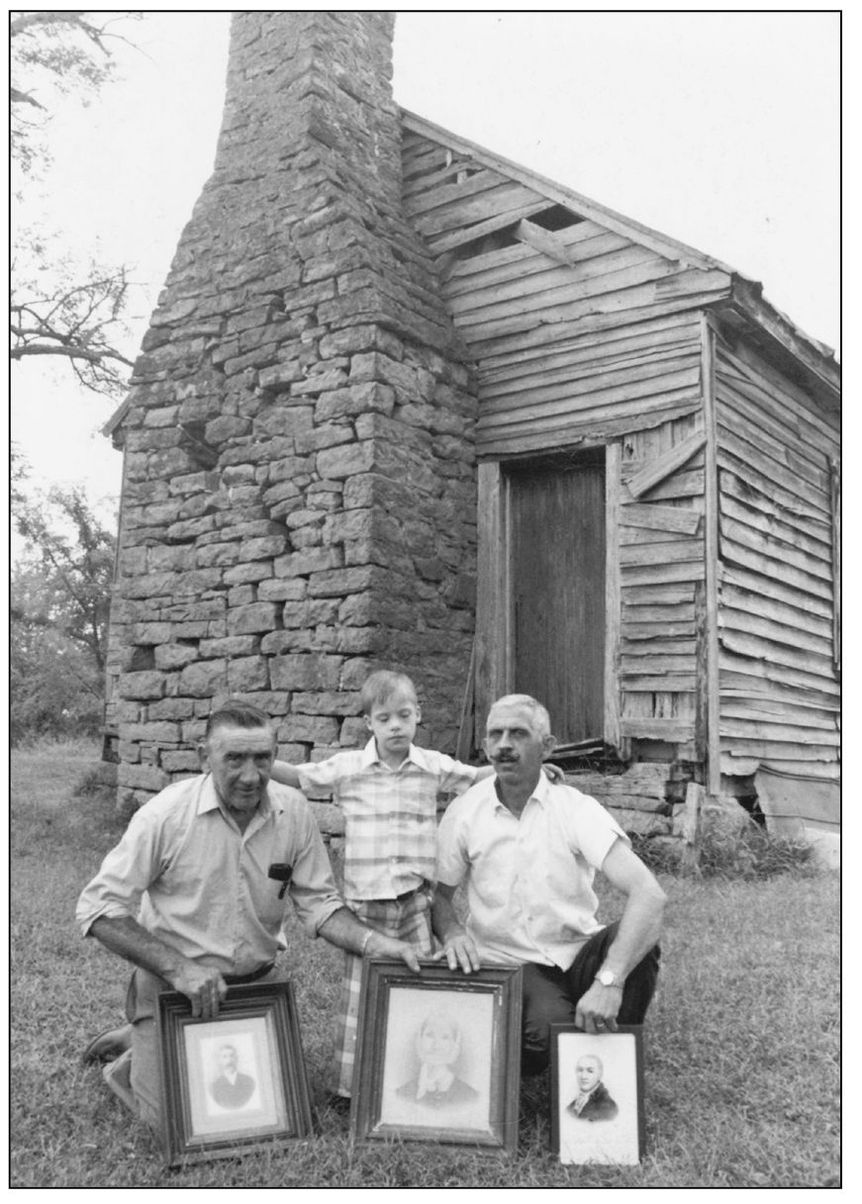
[{"xmin": 10, "ymin": 744, "xmax": 840, "ymax": 1188}]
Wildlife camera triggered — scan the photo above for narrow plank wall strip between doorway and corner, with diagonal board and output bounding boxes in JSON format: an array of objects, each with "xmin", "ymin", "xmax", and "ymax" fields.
[{"xmin": 619, "ymin": 413, "xmax": 704, "ymax": 761}]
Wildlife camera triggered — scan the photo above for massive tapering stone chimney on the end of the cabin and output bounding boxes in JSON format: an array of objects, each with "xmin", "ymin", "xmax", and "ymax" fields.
[{"xmin": 108, "ymin": 12, "xmax": 476, "ymax": 808}]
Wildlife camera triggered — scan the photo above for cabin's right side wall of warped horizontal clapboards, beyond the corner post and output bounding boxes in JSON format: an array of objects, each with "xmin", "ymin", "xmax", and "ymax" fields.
[{"xmin": 716, "ymin": 338, "xmax": 839, "ymax": 780}]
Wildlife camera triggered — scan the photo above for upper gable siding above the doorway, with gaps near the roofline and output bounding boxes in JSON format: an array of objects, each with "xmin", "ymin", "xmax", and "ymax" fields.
[{"xmin": 402, "ymin": 130, "xmax": 730, "ymax": 456}]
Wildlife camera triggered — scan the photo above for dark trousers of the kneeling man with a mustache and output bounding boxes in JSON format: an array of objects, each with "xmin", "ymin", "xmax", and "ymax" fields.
[{"xmin": 521, "ymin": 922, "xmax": 660, "ymax": 1074}]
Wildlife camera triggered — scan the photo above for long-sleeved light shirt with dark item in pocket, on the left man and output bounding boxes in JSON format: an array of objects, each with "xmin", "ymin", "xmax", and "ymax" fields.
[{"xmin": 76, "ymin": 774, "xmax": 343, "ymax": 975}]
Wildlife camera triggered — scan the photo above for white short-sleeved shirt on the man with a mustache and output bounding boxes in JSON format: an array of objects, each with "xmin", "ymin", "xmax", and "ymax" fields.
[{"xmin": 437, "ymin": 773, "xmax": 627, "ymax": 969}]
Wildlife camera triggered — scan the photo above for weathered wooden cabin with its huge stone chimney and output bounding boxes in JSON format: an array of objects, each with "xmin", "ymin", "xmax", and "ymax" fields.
[{"xmin": 102, "ymin": 12, "xmax": 839, "ymax": 847}]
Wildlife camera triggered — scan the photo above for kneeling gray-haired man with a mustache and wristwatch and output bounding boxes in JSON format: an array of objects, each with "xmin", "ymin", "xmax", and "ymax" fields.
[{"xmin": 433, "ymin": 695, "xmax": 665, "ymax": 1074}]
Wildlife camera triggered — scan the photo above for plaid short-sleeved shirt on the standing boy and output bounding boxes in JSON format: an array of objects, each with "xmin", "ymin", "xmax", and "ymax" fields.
[{"xmin": 296, "ymin": 737, "xmax": 478, "ymax": 901}]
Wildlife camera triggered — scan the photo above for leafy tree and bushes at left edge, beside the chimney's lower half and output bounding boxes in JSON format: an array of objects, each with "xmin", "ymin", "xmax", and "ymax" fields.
[{"xmin": 10, "ymin": 466, "xmax": 114, "ymax": 742}]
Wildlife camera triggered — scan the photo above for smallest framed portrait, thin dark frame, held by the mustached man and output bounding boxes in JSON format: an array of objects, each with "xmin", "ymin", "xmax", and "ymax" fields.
[{"xmin": 550, "ymin": 1025, "xmax": 644, "ymax": 1165}]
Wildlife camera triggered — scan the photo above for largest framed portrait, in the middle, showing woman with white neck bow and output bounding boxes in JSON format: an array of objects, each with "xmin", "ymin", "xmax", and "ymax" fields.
[{"xmin": 350, "ymin": 958, "xmax": 521, "ymax": 1152}]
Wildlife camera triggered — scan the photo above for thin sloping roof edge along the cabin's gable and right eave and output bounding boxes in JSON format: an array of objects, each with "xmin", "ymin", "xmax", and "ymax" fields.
[{"xmin": 401, "ymin": 108, "xmax": 840, "ymax": 391}]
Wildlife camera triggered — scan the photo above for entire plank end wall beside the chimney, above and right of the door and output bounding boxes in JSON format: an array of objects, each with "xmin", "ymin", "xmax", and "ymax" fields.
[{"xmin": 403, "ymin": 124, "xmax": 730, "ymax": 760}]
